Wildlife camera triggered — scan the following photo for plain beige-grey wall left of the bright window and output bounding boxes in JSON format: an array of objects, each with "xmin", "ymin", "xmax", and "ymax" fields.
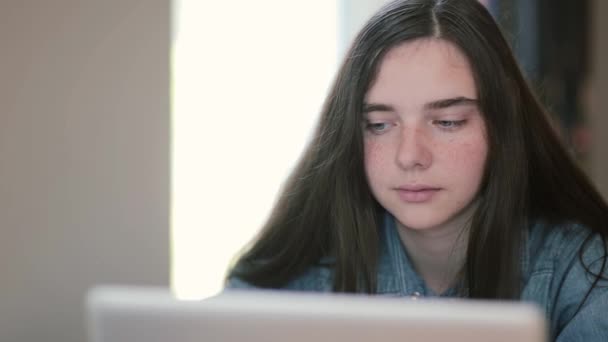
[{"xmin": 0, "ymin": 0, "xmax": 169, "ymax": 342}]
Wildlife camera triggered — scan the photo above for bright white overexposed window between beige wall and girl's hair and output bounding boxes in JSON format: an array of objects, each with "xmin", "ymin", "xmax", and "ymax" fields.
[{"xmin": 171, "ymin": 0, "xmax": 339, "ymax": 299}]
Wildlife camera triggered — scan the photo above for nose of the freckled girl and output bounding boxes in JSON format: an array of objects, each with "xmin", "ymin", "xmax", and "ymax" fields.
[{"xmin": 396, "ymin": 127, "xmax": 433, "ymax": 170}]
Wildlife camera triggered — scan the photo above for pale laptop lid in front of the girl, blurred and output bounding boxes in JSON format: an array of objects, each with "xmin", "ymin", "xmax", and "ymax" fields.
[{"xmin": 86, "ymin": 287, "xmax": 547, "ymax": 342}]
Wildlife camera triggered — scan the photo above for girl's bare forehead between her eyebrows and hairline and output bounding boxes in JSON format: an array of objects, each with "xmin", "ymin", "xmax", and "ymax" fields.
[{"xmin": 366, "ymin": 38, "xmax": 477, "ymax": 104}]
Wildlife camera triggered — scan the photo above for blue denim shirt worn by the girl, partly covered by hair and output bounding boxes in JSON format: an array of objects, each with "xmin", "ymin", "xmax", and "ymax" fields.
[{"xmin": 228, "ymin": 215, "xmax": 608, "ymax": 342}]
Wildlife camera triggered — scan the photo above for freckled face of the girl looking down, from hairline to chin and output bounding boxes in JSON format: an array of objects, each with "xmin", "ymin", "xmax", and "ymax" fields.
[{"xmin": 363, "ymin": 39, "xmax": 488, "ymax": 231}]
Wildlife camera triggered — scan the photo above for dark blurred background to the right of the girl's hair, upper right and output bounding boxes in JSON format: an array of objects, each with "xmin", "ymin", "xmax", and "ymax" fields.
[{"xmin": 490, "ymin": 0, "xmax": 600, "ymax": 166}]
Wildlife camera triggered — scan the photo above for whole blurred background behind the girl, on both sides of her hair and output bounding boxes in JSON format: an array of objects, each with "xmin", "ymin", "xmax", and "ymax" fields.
[{"xmin": 0, "ymin": 0, "xmax": 608, "ymax": 342}]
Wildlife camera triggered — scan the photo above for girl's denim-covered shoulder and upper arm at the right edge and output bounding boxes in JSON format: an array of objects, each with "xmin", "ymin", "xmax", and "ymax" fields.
[{"xmin": 524, "ymin": 224, "xmax": 608, "ymax": 341}]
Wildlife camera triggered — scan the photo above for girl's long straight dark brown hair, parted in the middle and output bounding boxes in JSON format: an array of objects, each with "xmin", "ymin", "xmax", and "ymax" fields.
[{"xmin": 228, "ymin": 0, "xmax": 608, "ymax": 299}]
